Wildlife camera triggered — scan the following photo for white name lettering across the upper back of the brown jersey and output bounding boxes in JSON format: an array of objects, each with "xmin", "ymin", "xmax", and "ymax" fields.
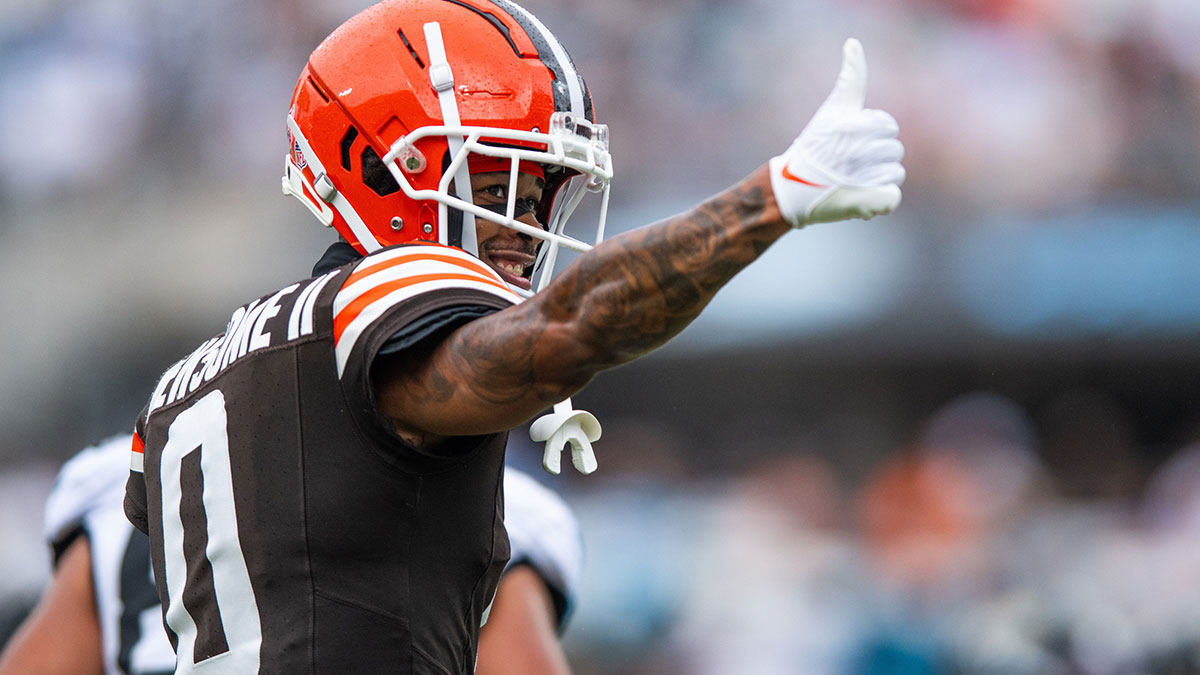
[{"xmin": 150, "ymin": 270, "xmax": 337, "ymax": 412}]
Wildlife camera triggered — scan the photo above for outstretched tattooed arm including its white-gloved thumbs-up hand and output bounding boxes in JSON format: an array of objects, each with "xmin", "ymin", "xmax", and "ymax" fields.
[{"xmin": 376, "ymin": 40, "xmax": 904, "ymax": 444}]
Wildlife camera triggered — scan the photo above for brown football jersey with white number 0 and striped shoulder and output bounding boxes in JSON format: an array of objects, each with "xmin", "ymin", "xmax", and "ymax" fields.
[{"xmin": 125, "ymin": 245, "xmax": 521, "ymax": 674}]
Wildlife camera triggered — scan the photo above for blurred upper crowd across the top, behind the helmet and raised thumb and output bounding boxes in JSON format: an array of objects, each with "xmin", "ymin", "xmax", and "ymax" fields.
[{"xmin": 0, "ymin": 0, "xmax": 1200, "ymax": 211}]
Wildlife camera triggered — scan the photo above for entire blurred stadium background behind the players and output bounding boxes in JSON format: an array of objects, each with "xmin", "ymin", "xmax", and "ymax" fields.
[{"xmin": 0, "ymin": 0, "xmax": 1200, "ymax": 675}]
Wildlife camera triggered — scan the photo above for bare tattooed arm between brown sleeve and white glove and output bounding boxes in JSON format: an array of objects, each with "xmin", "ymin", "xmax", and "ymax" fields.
[{"xmin": 374, "ymin": 167, "xmax": 792, "ymax": 446}]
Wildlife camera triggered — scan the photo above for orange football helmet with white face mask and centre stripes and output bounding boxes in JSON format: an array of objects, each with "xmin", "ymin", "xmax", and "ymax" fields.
[{"xmin": 283, "ymin": 0, "xmax": 612, "ymax": 289}]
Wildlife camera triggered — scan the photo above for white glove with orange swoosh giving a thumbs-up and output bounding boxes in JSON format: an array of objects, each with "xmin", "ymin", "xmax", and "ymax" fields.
[{"xmin": 768, "ymin": 38, "xmax": 905, "ymax": 227}]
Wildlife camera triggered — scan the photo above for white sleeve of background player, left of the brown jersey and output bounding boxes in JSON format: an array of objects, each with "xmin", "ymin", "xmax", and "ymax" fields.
[{"xmin": 43, "ymin": 434, "xmax": 131, "ymax": 563}]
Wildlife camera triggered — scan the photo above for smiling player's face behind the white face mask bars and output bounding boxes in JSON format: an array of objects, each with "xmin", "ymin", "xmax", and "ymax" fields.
[{"xmin": 470, "ymin": 172, "xmax": 546, "ymax": 289}]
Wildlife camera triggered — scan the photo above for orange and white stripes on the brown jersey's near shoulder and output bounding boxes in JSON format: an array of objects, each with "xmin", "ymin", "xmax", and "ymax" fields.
[{"xmin": 334, "ymin": 244, "xmax": 522, "ymax": 377}]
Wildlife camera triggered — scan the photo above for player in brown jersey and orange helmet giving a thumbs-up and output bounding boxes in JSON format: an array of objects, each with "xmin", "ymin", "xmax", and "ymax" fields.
[{"xmin": 125, "ymin": 0, "xmax": 904, "ymax": 674}]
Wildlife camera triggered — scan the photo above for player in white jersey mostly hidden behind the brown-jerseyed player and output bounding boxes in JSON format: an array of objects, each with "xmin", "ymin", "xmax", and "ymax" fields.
[{"xmin": 0, "ymin": 434, "xmax": 582, "ymax": 675}]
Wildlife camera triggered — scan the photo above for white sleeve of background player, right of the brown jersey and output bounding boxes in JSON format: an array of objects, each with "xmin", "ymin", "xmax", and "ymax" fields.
[{"xmin": 504, "ymin": 466, "xmax": 583, "ymax": 631}]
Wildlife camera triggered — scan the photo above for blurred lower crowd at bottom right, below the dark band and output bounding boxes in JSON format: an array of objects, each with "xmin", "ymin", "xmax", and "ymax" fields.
[{"xmin": 556, "ymin": 392, "xmax": 1200, "ymax": 675}]
